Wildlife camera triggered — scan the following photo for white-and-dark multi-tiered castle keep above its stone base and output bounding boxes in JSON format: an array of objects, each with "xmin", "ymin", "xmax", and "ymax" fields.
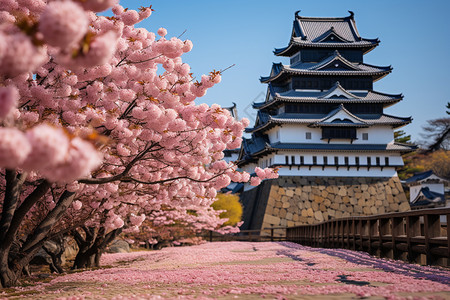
[{"xmin": 239, "ymin": 12, "xmax": 411, "ymax": 177}]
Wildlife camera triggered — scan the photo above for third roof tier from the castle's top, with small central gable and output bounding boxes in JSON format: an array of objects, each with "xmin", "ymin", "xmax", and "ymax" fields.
[{"xmin": 253, "ymin": 82, "xmax": 403, "ymax": 109}]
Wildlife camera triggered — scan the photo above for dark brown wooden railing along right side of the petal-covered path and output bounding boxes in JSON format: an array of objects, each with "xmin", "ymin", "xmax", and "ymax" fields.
[{"xmin": 286, "ymin": 208, "xmax": 450, "ymax": 265}]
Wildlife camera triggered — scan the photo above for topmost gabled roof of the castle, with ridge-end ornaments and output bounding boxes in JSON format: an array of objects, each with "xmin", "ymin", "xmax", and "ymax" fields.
[{"xmin": 274, "ymin": 11, "xmax": 380, "ymax": 56}]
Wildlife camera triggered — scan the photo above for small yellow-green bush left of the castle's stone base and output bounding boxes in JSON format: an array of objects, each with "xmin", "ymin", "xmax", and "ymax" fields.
[{"xmin": 211, "ymin": 194, "xmax": 243, "ymax": 226}]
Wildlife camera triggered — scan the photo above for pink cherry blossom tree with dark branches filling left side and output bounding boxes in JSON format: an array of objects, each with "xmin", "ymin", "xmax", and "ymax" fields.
[{"xmin": 0, "ymin": 0, "xmax": 277, "ymax": 287}]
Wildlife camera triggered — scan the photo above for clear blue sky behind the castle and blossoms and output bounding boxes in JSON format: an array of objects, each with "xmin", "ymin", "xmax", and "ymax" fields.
[{"xmin": 120, "ymin": 0, "xmax": 450, "ymax": 140}]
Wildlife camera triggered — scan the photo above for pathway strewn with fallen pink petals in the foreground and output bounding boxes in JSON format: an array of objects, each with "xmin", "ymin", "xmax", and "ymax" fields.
[{"xmin": 0, "ymin": 242, "xmax": 450, "ymax": 300}]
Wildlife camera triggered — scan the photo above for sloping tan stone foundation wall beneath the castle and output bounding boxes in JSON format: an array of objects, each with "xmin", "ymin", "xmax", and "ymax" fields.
[{"xmin": 241, "ymin": 176, "xmax": 410, "ymax": 237}]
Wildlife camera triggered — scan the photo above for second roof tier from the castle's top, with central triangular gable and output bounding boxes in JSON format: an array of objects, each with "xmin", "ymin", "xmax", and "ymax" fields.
[{"xmin": 260, "ymin": 51, "xmax": 392, "ymax": 83}]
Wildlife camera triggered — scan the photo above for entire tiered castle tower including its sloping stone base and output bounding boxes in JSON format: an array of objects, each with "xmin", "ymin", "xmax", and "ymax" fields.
[{"xmin": 238, "ymin": 12, "xmax": 414, "ymax": 229}]
